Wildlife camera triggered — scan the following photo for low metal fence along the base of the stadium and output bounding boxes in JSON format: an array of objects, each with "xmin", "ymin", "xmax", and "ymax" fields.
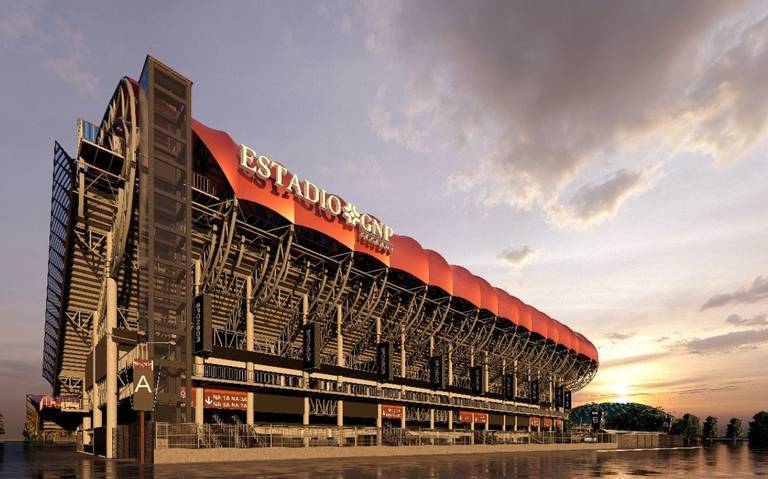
[{"xmin": 155, "ymin": 423, "xmax": 616, "ymax": 449}]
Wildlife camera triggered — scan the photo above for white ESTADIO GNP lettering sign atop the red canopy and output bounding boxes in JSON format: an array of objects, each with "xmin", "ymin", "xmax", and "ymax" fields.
[{"xmin": 240, "ymin": 145, "xmax": 394, "ymax": 253}]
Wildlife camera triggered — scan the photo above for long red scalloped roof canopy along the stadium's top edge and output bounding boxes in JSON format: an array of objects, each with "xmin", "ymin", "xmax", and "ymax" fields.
[{"xmin": 192, "ymin": 119, "xmax": 598, "ymax": 361}]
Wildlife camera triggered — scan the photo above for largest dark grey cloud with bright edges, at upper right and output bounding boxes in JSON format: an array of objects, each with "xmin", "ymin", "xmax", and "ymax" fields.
[{"xmin": 366, "ymin": 0, "xmax": 768, "ymax": 228}]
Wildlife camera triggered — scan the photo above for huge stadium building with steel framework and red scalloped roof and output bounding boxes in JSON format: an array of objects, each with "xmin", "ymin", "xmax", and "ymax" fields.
[{"xmin": 35, "ymin": 57, "xmax": 598, "ymax": 457}]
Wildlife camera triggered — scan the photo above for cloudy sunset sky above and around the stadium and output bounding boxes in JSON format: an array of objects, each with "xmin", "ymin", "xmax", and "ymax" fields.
[{"xmin": 0, "ymin": 0, "xmax": 768, "ymax": 438}]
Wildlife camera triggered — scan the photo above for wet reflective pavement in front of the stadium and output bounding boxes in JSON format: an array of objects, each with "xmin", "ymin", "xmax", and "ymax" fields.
[{"xmin": 0, "ymin": 443, "xmax": 768, "ymax": 479}]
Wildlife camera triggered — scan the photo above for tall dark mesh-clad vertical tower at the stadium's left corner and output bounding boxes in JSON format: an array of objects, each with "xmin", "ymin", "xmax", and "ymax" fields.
[{"xmin": 139, "ymin": 56, "xmax": 192, "ymax": 422}]
